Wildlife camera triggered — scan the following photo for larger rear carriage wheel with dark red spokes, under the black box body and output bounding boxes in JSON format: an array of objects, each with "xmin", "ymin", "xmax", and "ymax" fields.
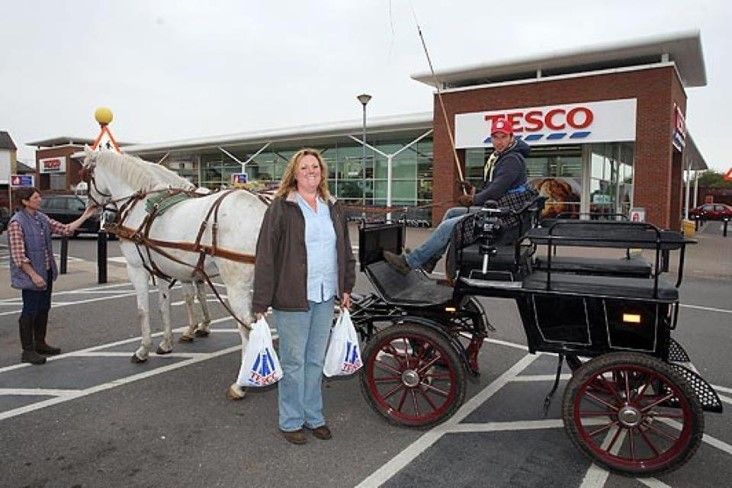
[{"xmin": 562, "ymin": 353, "xmax": 704, "ymax": 475}]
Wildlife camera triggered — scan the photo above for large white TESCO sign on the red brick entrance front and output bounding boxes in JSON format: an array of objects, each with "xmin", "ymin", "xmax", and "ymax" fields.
[{"xmin": 455, "ymin": 98, "xmax": 637, "ymax": 149}]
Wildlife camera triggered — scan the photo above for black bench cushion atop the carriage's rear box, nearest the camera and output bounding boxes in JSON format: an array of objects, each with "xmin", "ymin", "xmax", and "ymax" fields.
[{"xmin": 523, "ymin": 270, "xmax": 679, "ymax": 302}]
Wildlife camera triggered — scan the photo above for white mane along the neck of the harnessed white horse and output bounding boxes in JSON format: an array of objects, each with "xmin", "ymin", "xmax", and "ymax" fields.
[{"xmin": 91, "ymin": 151, "xmax": 195, "ymax": 191}]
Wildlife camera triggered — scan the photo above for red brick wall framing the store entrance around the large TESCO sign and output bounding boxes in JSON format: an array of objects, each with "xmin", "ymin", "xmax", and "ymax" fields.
[{"xmin": 433, "ymin": 67, "xmax": 686, "ymax": 228}]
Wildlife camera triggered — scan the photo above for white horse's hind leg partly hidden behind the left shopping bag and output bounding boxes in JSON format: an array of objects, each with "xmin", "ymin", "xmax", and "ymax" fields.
[{"xmin": 217, "ymin": 260, "xmax": 254, "ymax": 400}]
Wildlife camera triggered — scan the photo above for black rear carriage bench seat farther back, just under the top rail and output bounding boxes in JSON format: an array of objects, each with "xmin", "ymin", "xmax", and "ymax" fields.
[{"xmin": 533, "ymin": 256, "xmax": 652, "ymax": 278}]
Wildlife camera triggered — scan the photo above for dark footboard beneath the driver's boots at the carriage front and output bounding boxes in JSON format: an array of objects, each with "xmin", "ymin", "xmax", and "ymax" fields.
[{"xmin": 365, "ymin": 261, "xmax": 453, "ymax": 307}]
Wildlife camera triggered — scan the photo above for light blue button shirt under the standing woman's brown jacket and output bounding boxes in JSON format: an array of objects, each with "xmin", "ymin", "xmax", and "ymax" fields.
[{"xmin": 297, "ymin": 193, "xmax": 338, "ymax": 303}]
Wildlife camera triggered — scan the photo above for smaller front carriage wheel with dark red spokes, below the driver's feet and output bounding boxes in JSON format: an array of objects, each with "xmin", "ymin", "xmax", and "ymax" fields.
[{"xmin": 360, "ymin": 324, "xmax": 465, "ymax": 427}]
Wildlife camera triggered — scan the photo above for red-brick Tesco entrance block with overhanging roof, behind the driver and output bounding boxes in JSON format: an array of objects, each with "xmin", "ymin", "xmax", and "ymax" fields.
[{"xmin": 424, "ymin": 33, "xmax": 706, "ymax": 229}]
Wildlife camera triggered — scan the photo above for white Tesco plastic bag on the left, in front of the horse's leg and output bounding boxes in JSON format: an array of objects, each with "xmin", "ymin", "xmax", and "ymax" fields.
[{"xmin": 237, "ymin": 318, "xmax": 282, "ymax": 386}]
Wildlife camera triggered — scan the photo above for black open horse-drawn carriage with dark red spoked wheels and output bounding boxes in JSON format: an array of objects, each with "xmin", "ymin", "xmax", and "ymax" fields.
[{"xmin": 352, "ymin": 196, "xmax": 722, "ymax": 475}]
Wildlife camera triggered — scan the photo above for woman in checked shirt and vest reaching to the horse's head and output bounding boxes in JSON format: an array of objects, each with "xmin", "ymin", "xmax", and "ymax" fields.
[{"xmin": 8, "ymin": 188, "xmax": 96, "ymax": 364}]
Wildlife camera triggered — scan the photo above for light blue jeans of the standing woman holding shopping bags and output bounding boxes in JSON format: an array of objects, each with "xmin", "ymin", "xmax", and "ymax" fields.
[{"xmin": 274, "ymin": 298, "xmax": 335, "ymax": 432}]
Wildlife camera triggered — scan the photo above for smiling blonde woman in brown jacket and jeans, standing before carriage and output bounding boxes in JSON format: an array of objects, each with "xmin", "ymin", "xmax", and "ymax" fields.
[{"xmin": 252, "ymin": 149, "xmax": 356, "ymax": 444}]
